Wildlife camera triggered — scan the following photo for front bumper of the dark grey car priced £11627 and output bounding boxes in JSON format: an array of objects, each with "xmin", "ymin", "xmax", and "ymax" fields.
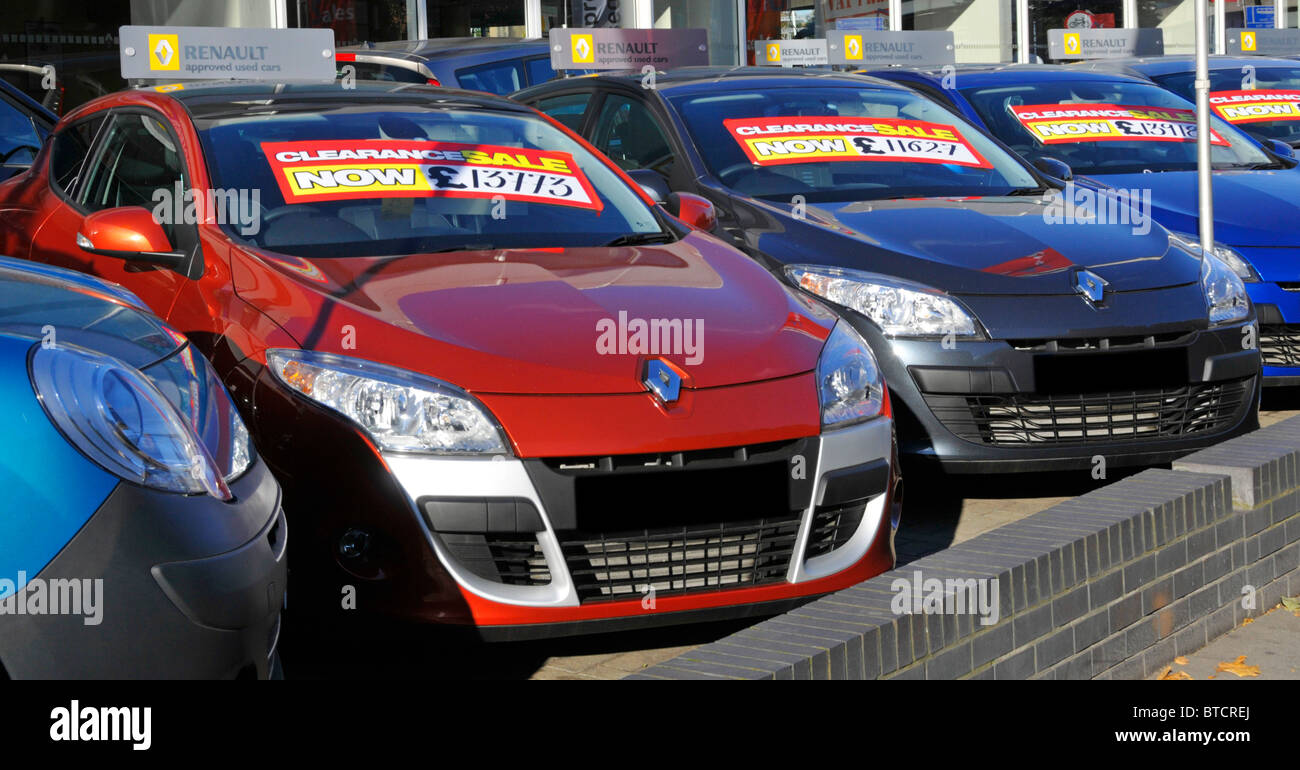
[{"xmin": 846, "ymin": 298, "xmax": 1260, "ymax": 473}]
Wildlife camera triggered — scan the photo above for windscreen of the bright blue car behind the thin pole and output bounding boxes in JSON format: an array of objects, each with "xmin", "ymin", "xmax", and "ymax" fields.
[{"xmin": 961, "ymin": 81, "xmax": 1275, "ymax": 174}]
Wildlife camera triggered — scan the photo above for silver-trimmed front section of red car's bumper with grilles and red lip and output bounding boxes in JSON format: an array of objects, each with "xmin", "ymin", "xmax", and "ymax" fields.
[{"xmin": 385, "ymin": 418, "xmax": 898, "ymax": 639}]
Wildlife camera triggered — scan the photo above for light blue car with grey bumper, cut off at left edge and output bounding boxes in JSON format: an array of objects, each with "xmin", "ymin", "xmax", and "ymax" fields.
[{"xmin": 0, "ymin": 258, "xmax": 287, "ymax": 679}]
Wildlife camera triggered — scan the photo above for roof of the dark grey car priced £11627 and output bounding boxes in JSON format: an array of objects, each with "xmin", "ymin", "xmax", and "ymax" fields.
[{"xmin": 512, "ymin": 66, "xmax": 898, "ymax": 91}]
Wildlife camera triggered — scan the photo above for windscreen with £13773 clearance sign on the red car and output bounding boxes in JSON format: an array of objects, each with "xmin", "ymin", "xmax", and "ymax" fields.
[{"xmin": 196, "ymin": 104, "xmax": 663, "ymax": 258}]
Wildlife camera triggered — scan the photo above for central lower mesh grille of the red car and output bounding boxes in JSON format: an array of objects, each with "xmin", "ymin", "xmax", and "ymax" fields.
[{"xmin": 560, "ymin": 516, "xmax": 800, "ymax": 602}]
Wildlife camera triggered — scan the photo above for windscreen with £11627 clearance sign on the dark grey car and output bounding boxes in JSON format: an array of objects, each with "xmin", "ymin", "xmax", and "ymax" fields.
[{"xmin": 670, "ymin": 86, "xmax": 1037, "ymax": 202}]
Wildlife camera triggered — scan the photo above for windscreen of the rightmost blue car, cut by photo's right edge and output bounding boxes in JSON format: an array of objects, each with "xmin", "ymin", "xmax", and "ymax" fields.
[{"xmin": 1152, "ymin": 66, "xmax": 1300, "ymax": 144}]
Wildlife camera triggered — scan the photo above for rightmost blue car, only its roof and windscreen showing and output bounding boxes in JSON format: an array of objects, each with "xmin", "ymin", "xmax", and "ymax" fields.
[{"xmin": 1073, "ymin": 56, "xmax": 1300, "ymax": 148}]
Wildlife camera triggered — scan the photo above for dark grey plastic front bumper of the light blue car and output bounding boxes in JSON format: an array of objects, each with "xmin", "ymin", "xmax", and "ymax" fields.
[{"xmin": 0, "ymin": 459, "xmax": 287, "ymax": 679}]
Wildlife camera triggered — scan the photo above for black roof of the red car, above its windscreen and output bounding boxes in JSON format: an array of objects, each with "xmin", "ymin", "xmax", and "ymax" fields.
[{"xmin": 154, "ymin": 81, "xmax": 533, "ymax": 120}]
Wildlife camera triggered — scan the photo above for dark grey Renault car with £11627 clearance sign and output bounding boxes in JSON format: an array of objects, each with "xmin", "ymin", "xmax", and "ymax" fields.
[{"xmin": 515, "ymin": 68, "xmax": 1260, "ymax": 472}]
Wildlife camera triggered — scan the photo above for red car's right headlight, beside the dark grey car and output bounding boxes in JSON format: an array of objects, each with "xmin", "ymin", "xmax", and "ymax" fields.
[{"xmin": 816, "ymin": 321, "xmax": 884, "ymax": 428}]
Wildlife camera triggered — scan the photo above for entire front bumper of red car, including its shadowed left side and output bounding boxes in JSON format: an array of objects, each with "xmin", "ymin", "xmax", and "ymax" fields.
[{"xmin": 247, "ymin": 363, "xmax": 900, "ymax": 639}]
